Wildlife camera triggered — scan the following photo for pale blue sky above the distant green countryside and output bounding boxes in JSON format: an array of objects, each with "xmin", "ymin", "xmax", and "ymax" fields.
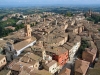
[{"xmin": 0, "ymin": 0, "xmax": 100, "ymax": 6}]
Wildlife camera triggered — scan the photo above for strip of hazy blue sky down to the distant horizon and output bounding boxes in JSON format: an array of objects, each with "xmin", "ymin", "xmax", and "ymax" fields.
[{"xmin": 0, "ymin": 0, "xmax": 100, "ymax": 7}]
